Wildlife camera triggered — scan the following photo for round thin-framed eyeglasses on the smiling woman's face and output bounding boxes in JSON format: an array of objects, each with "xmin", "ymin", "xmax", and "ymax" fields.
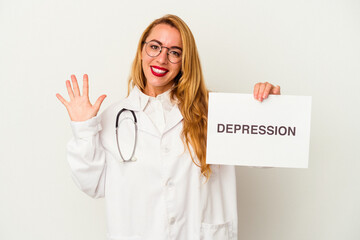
[{"xmin": 144, "ymin": 40, "xmax": 182, "ymax": 63}]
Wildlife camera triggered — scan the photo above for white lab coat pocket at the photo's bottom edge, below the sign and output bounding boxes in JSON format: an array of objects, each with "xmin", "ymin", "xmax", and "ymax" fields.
[{"xmin": 200, "ymin": 221, "xmax": 236, "ymax": 240}]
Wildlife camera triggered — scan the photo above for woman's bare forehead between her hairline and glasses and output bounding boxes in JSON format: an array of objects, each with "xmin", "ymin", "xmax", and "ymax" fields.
[{"xmin": 146, "ymin": 24, "xmax": 182, "ymax": 48}]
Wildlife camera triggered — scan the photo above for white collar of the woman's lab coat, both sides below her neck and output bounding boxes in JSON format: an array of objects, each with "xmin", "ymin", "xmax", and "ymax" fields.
[{"xmin": 122, "ymin": 86, "xmax": 183, "ymax": 137}]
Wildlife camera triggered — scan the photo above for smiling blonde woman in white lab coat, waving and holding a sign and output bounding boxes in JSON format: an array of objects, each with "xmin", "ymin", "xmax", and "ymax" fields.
[{"xmin": 57, "ymin": 15, "xmax": 280, "ymax": 240}]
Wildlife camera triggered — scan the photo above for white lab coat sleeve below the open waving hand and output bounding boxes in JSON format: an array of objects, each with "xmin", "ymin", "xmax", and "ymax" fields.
[{"xmin": 67, "ymin": 116, "xmax": 106, "ymax": 198}]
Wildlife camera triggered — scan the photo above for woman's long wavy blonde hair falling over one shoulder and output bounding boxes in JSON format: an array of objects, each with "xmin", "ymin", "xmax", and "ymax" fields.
[{"xmin": 128, "ymin": 15, "xmax": 211, "ymax": 180}]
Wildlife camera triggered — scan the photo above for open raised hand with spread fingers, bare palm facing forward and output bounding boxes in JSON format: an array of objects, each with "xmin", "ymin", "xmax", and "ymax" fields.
[{"xmin": 56, "ymin": 74, "xmax": 106, "ymax": 122}]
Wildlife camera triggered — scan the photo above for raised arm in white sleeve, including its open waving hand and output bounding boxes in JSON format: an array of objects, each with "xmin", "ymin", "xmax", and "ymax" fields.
[{"xmin": 56, "ymin": 74, "xmax": 106, "ymax": 198}]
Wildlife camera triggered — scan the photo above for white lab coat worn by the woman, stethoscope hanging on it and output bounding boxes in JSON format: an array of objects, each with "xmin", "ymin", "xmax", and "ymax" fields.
[{"xmin": 68, "ymin": 87, "xmax": 237, "ymax": 240}]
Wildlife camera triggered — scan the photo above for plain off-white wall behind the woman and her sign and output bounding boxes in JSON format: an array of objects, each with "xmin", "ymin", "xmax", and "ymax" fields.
[{"xmin": 0, "ymin": 0, "xmax": 360, "ymax": 240}]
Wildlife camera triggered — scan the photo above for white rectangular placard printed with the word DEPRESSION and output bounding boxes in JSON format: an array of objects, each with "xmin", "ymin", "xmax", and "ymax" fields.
[{"xmin": 206, "ymin": 93, "xmax": 311, "ymax": 168}]
